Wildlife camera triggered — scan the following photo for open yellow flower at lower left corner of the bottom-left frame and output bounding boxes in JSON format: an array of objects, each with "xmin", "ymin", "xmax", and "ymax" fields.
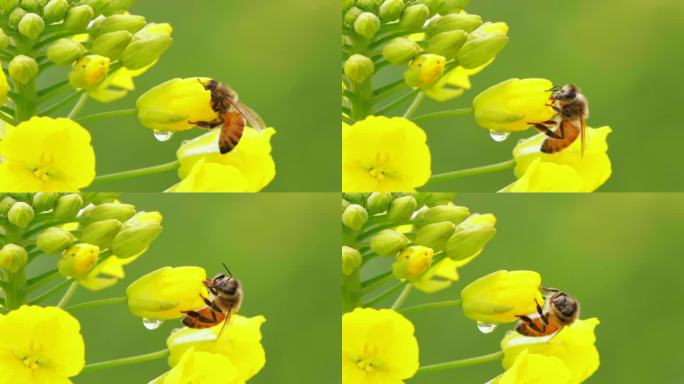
[{"xmin": 0, "ymin": 306, "xmax": 85, "ymax": 384}]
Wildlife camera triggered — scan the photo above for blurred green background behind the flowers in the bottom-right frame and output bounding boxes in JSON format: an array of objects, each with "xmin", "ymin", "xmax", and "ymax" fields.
[{"xmin": 360, "ymin": 193, "xmax": 684, "ymax": 384}]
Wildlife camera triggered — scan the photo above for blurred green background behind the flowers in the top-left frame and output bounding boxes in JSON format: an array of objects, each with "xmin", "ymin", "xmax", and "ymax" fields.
[{"xmin": 40, "ymin": 0, "xmax": 340, "ymax": 192}]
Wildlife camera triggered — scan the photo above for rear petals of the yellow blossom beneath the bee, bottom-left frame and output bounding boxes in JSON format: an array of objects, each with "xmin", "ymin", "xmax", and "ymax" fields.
[{"xmin": 166, "ymin": 314, "xmax": 266, "ymax": 383}]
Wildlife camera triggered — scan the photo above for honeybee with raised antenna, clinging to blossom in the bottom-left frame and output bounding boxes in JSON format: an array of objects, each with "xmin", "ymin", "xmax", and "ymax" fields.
[{"xmin": 183, "ymin": 264, "xmax": 243, "ymax": 338}]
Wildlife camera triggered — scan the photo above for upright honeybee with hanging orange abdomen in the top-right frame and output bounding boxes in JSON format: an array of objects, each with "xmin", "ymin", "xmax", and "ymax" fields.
[{"xmin": 529, "ymin": 84, "xmax": 589, "ymax": 156}]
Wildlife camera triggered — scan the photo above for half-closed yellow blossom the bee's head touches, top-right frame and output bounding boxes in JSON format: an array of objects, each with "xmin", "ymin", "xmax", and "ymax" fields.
[{"xmin": 473, "ymin": 79, "xmax": 556, "ymax": 132}]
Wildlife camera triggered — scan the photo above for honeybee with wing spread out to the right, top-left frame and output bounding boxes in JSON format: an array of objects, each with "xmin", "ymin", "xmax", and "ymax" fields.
[{"xmin": 189, "ymin": 79, "xmax": 266, "ymax": 155}]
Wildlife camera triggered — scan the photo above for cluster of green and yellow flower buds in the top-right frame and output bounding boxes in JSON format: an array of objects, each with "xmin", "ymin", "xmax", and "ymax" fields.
[{"xmin": 342, "ymin": 0, "xmax": 508, "ymax": 89}]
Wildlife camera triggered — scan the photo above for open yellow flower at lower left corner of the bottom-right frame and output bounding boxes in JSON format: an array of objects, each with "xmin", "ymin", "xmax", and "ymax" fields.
[{"xmin": 342, "ymin": 308, "xmax": 419, "ymax": 384}]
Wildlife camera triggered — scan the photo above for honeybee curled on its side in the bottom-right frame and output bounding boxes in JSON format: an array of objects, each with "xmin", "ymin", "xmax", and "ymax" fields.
[{"xmin": 515, "ymin": 288, "xmax": 579, "ymax": 337}]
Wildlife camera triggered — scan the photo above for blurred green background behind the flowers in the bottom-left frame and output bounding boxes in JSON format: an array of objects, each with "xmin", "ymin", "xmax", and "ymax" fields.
[{"xmin": 28, "ymin": 193, "xmax": 340, "ymax": 384}]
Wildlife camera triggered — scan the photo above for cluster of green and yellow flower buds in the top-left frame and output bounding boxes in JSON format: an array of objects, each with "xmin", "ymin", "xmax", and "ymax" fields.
[{"xmin": 0, "ymin": 0, "xmax": 172, "ymax": 90}]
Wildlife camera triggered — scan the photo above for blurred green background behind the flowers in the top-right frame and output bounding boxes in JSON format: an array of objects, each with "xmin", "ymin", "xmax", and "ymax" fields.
[{"xmin": 374, "ymin": 0, "xmax": 684, "ymax": 192}]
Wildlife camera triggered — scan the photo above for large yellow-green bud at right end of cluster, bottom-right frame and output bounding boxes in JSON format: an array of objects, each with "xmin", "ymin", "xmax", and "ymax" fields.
[{"xmin": 446, "ymin": 213, "xmax": 496, "ymax": 260}]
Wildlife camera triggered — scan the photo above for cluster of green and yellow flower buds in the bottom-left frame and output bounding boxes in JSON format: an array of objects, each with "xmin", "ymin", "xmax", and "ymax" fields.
[{"xmin": 0, "ymin": 193, "xmax": 162, "ymax": 290}]
